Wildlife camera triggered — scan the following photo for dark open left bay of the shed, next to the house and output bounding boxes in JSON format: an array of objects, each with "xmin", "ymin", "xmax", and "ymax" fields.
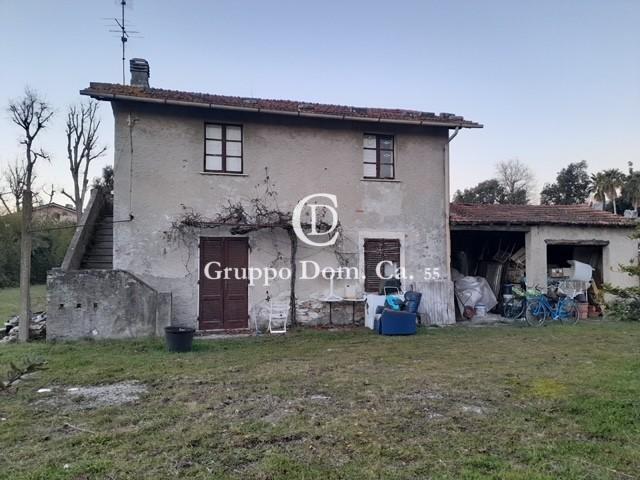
[{"xmin": 451, "ymin": 230, "xmax": 526, "ymax": 319}]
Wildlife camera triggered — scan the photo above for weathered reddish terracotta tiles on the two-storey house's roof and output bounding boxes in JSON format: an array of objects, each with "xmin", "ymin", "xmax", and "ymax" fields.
[{"xmin": 80, "ymin": 82, "xmax": 482, "ymax": 128}]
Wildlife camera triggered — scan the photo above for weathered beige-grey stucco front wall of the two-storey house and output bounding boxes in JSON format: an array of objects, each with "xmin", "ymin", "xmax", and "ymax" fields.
[{"xmin": 107, "ymin": 103, "xmax": 453, "ymax": 327}]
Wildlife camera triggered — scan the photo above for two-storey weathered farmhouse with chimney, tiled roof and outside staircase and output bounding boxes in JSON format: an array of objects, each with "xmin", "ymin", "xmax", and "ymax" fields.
[{"xmin": 48, "ymin": 59, "xmax": 635, "ymax": 338}]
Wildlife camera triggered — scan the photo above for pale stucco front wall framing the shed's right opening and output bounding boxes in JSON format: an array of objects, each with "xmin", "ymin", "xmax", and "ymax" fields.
[{"xmin": 525, "ymin": 225, "xmax": 638, "ymax": 287}]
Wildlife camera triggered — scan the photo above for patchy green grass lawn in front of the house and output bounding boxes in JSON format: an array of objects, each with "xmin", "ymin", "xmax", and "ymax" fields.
[{"xmin": 0, "ymin": 322, "xmax": 640, "ymax": 480}]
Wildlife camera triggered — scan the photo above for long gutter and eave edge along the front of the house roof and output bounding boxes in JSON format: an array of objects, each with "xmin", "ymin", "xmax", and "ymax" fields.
[{"xmin": 80, "ymin": 88, "xmax": 484, "ymax": 128}]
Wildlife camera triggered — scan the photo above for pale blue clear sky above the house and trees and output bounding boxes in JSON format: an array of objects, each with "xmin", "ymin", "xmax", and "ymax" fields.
[{"xmin": 0, "ymin": 0, "xmax": 640, "ymax": 204}]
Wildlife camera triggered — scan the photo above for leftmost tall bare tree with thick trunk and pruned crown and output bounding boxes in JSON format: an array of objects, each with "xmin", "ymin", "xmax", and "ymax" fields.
[{"xmin": 8, "ymin": 87, "xmax": 53, "ymax": 341}]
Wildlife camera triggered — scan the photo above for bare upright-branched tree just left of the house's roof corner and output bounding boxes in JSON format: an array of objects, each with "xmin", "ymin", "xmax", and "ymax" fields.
[{"xmin": 62, "ymin": 100, "xmax": 107, "ymax": 223}]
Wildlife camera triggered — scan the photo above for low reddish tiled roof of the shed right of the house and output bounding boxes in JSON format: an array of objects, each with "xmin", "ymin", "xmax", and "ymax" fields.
[{"xmin": 450, "ymin": 203, "xmax": 637, "ymax": 227}]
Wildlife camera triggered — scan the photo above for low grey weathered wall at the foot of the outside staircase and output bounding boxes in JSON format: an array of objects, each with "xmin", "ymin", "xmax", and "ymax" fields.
[{"xmin": 47, "ymin": 269, "xmax": 171, "ymax": 340}]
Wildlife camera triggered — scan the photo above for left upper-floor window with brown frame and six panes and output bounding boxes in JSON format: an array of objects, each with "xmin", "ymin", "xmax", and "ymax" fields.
[{"xmin": 204, "ymin": 123, "xmax": 242, "ymax": 173}]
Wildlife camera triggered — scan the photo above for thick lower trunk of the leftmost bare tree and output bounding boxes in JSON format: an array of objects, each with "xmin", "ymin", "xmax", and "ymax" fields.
[{"xmin": 18, "ymin": 190, "xmax": 33, "ymax": 342}]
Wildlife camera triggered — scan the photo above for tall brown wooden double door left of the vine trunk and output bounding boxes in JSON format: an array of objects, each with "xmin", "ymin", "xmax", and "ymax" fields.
[{"xmin": 198, "ymin": 238, "xmax": 249, "ymax": 330}]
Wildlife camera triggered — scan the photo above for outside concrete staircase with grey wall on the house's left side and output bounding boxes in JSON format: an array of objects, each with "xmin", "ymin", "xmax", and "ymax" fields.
[{"xmin": 47, "ymin": 188, "xmax": 172, "ymax": 340}]
